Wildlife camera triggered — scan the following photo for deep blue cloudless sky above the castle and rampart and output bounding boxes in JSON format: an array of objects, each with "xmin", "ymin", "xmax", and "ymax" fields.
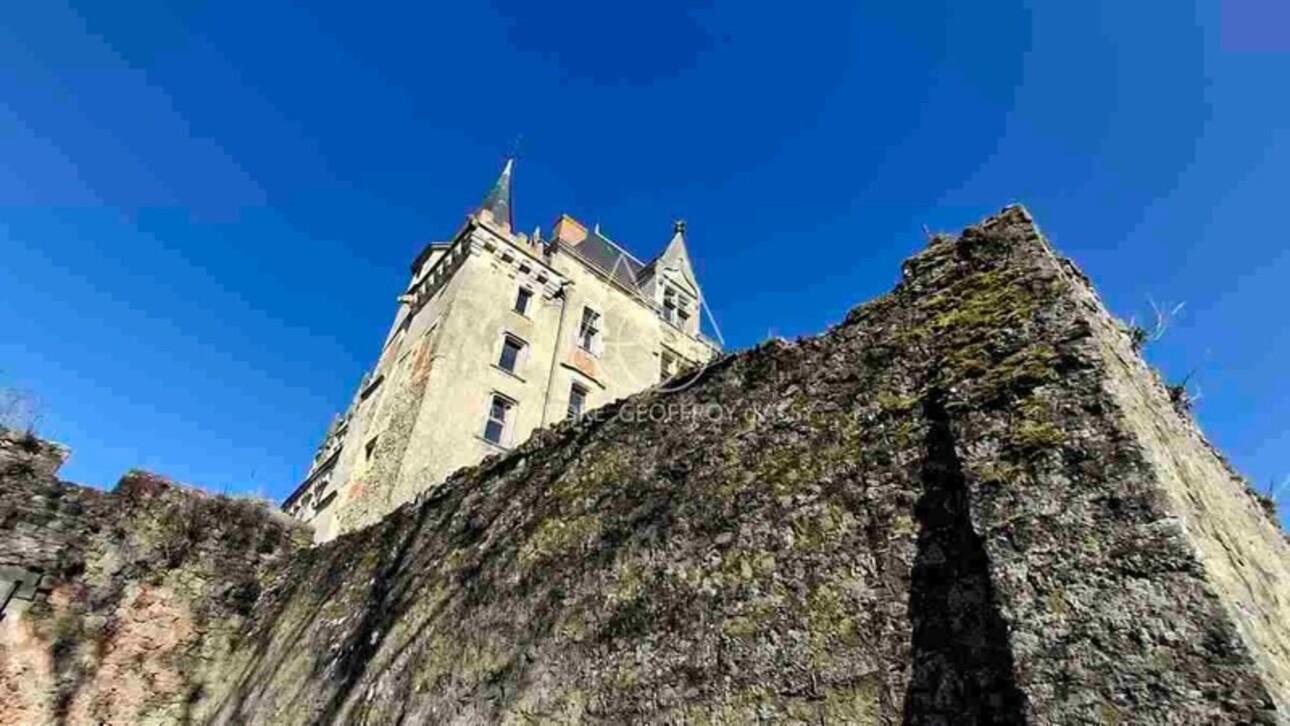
[{"xmin": 0, "ymin": 0, "xmax": 1290, "ymax": 523}]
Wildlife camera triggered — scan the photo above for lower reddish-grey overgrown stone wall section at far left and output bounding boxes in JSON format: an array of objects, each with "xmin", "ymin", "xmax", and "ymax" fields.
[{"xmin": 0, "ymin": 431, "xmax": 308, "ymax": 725}]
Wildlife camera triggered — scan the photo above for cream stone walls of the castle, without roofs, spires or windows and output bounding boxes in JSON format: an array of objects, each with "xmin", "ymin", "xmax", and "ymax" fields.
[{"xmin": 295, "ymin": 217, "xmax": 719, "ymax": 542}]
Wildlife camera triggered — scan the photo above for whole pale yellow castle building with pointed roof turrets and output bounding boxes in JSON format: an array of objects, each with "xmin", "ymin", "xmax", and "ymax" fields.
[{"xmin": 283, "ymin": 161, "xmax": 720, "ymax": 542}]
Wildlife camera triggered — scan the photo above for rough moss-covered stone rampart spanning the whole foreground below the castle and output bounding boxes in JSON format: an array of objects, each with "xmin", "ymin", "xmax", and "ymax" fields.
[{"xmin": 0, "ymin": 208, "xmax": 1290, "ymax": 725}]
